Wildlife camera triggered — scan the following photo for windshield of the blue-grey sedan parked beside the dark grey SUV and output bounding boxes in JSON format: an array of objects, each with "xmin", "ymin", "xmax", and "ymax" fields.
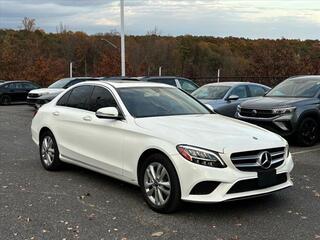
[{"xmin": 191, "ymin": 85, "xmax": 230, "ymax": 99}]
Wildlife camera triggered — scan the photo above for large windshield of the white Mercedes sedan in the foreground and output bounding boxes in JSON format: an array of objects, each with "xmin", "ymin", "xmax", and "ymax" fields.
[{"xmin": 118, "ymin": 87, "xmax": 211, "ymax": 118}]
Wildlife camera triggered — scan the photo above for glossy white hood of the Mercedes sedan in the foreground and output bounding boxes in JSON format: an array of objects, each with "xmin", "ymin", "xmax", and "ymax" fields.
[{"xmin": 135, "ymin": 114, "xmax": 285, "ymax": 153}]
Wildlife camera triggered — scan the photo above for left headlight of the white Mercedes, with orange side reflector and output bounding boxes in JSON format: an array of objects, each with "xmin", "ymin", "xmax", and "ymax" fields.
[{"xmin": 177, "ymin": 145, "xmax": 226, "ymax": 168}]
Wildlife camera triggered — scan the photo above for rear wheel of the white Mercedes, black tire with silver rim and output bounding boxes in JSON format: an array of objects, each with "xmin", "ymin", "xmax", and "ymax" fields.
[{"xmin": 39, "ymin": 131, "xmax": 62, "ymax": 171}]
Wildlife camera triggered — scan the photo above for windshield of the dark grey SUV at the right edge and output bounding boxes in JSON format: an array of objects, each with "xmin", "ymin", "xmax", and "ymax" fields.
[{"xmin": 266, "ymin": 78, "xmax": 320, "ymax": 98}]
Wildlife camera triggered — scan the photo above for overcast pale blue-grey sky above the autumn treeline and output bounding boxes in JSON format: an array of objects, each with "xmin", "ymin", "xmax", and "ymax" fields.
[{"xmin": 0, "ymin": 0, "xmax": 320, "ymax": 39}]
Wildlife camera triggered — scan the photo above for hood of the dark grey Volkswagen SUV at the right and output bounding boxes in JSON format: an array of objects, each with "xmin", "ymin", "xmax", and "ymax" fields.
[{"xmin": 240, "ymin": 97, "xmax": 319, "ymax": 109}]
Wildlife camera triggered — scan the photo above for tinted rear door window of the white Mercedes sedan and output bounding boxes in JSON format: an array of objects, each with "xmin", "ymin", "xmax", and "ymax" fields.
[{"xmin": 65, "ymin": 86, "xmax": 93, "ymax": 110}]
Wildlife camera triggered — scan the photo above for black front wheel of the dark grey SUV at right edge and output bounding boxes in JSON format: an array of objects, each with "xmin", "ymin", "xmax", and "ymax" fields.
[{"xmin": 296, "ymin": 117, "xmax": 320, "ymax": 147}]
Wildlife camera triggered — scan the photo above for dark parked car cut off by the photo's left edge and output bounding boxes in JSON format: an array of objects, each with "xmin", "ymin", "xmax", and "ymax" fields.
[{"xmin": 0, "ymin": 81, "xmax": 40, "ymax": 105}]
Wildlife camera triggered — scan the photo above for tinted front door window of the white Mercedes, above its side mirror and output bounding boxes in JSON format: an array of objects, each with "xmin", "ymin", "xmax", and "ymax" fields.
[{"xmin": 89, "ymin": 87, "xmax": 117, "ymax": 112}]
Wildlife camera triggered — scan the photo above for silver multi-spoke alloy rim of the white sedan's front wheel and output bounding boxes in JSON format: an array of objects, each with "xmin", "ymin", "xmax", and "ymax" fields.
[{"xmin": 144, "ymin": 162, "xmax": 171, "ymax": 207}]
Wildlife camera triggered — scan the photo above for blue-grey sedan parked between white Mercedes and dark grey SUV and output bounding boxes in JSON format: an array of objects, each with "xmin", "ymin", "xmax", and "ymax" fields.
[{"xmin": 191, "ymin": 82, "xmax": 270, "ymax": 117}]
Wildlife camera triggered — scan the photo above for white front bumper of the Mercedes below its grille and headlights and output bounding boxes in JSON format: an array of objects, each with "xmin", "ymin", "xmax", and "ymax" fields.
[{"xmin": 174, "ymin": 152, "xmax": 294, "ymax": 203}]
